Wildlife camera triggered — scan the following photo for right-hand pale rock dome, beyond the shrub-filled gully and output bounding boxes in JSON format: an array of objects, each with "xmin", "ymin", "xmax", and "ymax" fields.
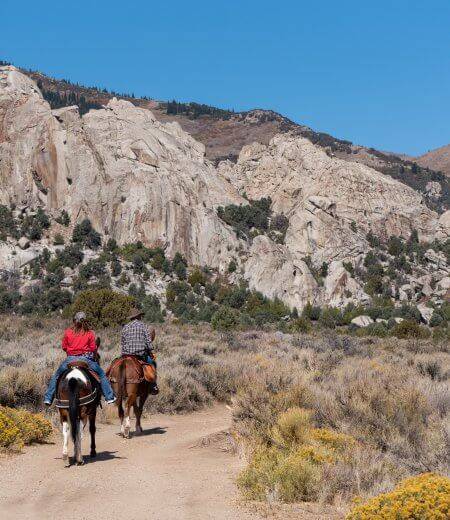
[{"xmin": 219, "ymin": 135, "xmax": 438, "ymax": 264}]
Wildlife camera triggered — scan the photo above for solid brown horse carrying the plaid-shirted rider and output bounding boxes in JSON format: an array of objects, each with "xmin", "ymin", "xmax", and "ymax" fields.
[{"xmin": 106, "ymin": 329, "xmax": 155, "ymax": 439}]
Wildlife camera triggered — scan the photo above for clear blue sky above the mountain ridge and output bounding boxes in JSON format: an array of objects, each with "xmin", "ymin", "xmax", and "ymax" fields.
[{"xmin": 0, "ymin": 0, "xmax": 450, "ymax": 154}]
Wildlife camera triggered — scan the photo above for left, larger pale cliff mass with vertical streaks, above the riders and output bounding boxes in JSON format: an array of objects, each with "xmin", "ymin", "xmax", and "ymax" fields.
[{"xmin": 0, "ymin": 67, "xmax": 243, "ymax": 266}]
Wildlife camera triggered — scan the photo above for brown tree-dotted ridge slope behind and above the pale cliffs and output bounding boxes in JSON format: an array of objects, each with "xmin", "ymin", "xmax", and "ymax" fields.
[{"xmin": 4, "ymin": 62, "xmax": 450, "ymax": 212}]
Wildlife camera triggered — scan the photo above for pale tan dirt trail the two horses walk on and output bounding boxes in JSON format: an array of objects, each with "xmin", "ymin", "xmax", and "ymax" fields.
[{"xmin": 0, "ymin": 407, "xmax": 260, "ymax": 520}]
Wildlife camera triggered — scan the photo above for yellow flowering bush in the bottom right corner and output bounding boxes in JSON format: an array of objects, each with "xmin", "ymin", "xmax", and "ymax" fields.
[{"xmin": 346, "ymin": 473, "xmax": 450, "ymax": 520}]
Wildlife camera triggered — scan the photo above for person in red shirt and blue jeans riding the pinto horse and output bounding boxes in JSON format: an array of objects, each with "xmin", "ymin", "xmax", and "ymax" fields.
[{"xmin": 44, "ymin": 312, "xmax": 116, "ymax": 406}]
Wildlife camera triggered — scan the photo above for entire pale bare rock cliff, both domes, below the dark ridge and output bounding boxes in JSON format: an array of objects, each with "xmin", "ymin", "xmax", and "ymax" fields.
[{"xmin": 0, "ymin": 67, "xmax": 450, "ymax": 308}]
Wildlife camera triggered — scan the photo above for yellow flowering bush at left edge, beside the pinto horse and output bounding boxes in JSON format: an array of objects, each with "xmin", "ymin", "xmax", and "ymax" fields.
[{"xmin": 0, "ymin": 406, "xmax": 52, "ymax": 449}]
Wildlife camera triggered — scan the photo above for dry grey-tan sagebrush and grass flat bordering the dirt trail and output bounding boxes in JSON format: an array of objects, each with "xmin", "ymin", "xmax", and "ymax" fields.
[{"xmin": 0, "ymin": 317, "xmax": 450, "ymax": 503}]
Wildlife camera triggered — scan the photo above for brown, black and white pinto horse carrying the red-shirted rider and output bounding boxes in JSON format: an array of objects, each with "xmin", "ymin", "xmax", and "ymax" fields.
[{"xmin": 56, "ymin": 361, "xmax": 101, "ymax": 467}]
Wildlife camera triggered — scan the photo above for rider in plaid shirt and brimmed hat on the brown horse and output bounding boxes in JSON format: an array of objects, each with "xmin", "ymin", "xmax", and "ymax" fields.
[{"xmin": 121, "ymin": 308, "xmax": 159, "ymax": 394}]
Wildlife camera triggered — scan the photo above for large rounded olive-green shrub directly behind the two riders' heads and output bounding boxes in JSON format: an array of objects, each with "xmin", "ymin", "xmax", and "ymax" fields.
[{"xmin": 65, "ymin": 289, "xmax": 135, "ymax": 328}]
